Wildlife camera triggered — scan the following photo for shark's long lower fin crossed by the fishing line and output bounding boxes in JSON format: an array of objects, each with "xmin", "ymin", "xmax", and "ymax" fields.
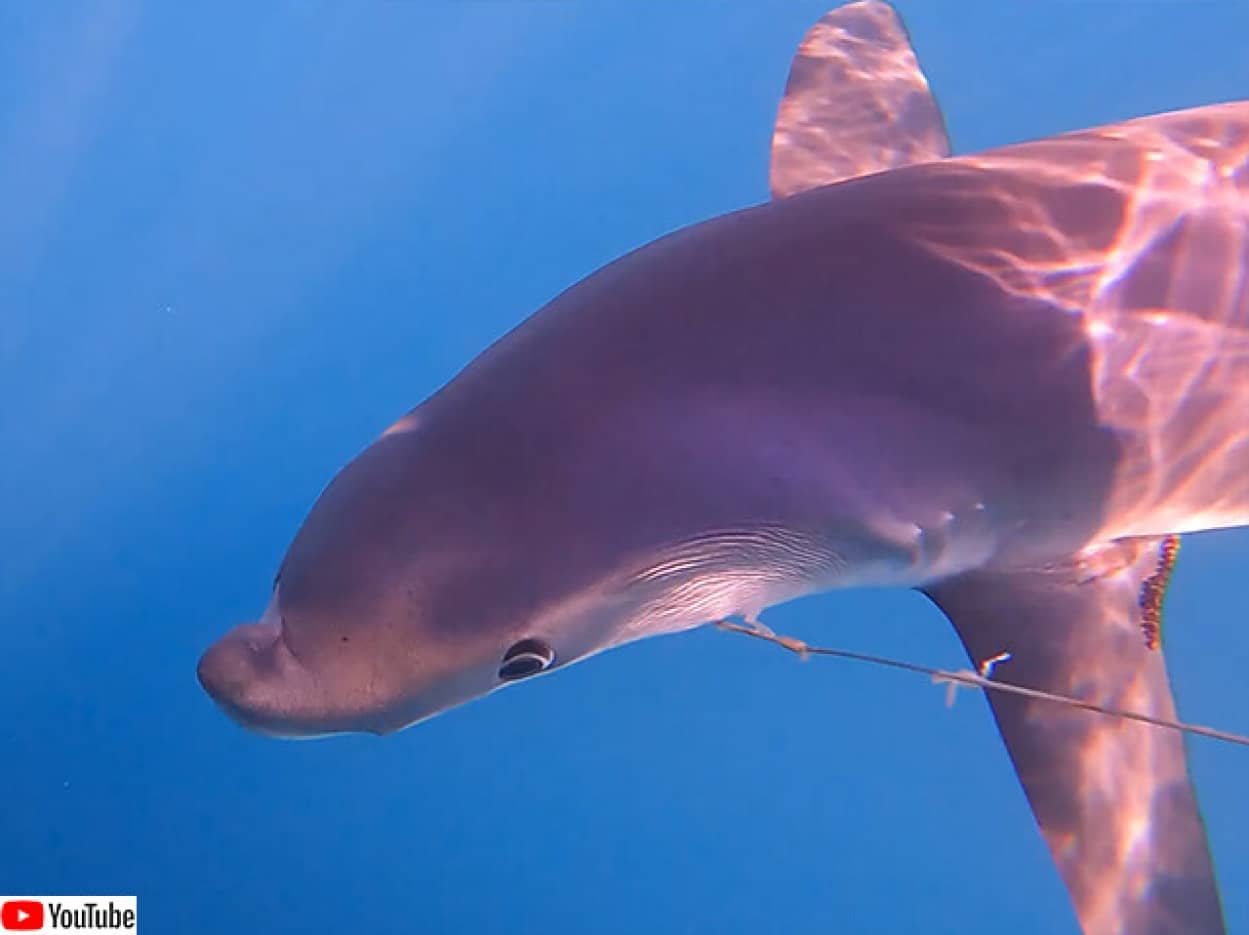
[{"xmin": 927, "ymin": 537, "xmax": 1224, "ymax": 935}]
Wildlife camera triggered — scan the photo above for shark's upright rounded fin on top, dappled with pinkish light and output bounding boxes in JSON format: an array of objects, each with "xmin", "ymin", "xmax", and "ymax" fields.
[{"xmin": 769, "ymin": 0, "xmax": 949, "ymax": 198}]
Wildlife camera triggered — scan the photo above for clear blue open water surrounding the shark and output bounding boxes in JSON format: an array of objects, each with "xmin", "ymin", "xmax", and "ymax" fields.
[{"xmin": 0, "ymin": 0, "xmax": 1249, "ymax": 935}]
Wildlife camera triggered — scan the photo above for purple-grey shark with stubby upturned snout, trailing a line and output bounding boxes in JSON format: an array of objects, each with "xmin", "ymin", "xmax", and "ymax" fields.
[{"xmin": 199, "ymin": 0, "xmax": 1249, "ymax": 935}]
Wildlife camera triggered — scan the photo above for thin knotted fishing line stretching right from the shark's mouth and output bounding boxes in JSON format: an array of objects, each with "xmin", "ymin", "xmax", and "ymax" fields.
[{"xmin": 716, "ymin": 620, "xmax": 1249, "ymax": 747}]
